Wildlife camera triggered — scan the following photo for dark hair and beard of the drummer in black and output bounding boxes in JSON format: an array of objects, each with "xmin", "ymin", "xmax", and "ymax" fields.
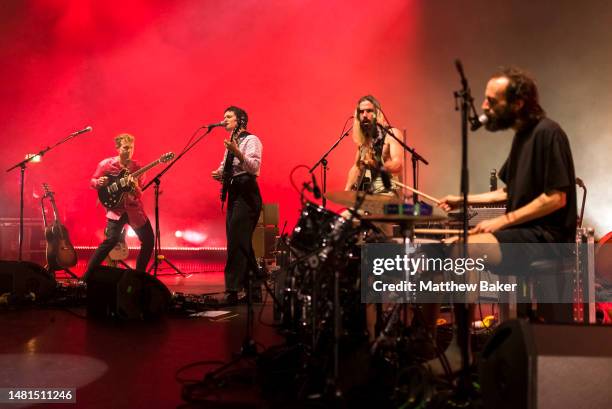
[{"xmin": 491, "ymin": 67, "xmax": 546, "ymax": 123}]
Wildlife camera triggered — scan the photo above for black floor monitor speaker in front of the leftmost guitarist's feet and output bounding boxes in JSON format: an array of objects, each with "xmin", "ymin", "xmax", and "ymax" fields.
[{"xmin": 87, "ymin": 266, "xmax": 172, "ymax": 320}]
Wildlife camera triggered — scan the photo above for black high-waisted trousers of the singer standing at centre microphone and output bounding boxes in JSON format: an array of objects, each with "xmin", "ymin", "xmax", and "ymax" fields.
[{"xmin": 225, "ymin": 174, "xmax": 262, "ymax": 292}]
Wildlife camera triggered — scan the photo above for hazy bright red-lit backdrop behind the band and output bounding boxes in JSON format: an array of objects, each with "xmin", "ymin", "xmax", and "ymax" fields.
[{"xmin": 0, "ymin": 0, "xmax": 426, "ymax": 245}]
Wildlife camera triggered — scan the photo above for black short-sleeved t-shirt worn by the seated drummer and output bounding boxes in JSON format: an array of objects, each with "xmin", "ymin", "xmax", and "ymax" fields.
[{"xmin": 499, "ymin": 118, "xmax": 576, "ymax": 242}]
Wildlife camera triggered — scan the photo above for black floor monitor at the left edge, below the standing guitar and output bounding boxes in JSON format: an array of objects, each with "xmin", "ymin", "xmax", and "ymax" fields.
[{"xmin": 0, "ymin": 260, "xmax": 56, "ymax": 300}]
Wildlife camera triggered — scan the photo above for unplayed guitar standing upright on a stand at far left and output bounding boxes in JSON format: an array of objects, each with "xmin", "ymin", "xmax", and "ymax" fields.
[{"xmin": 40, "ymin": 183, "xmax": 77, "ymax": 271}]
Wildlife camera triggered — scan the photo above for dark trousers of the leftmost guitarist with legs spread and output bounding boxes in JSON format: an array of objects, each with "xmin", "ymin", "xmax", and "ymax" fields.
[{"xmin": 83, "ymin": 213, "xmax": 155, "ymax": 280}]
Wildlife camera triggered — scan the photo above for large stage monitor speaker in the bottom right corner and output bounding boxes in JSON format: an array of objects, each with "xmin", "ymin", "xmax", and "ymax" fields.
[{"xmin": 479, "ymin": 320, "xmax": 612, "ymax": 409}]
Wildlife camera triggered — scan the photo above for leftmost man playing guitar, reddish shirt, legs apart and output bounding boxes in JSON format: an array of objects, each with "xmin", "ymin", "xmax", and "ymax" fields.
[{"xmin": 84, "ymin": 133, "xmax": 155, "ymax": 280}]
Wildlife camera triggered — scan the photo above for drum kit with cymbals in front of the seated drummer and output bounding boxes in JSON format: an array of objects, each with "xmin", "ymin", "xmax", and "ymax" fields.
[{"xmin": 280, "ymin": 186, "xmax": 446, "ymax": 392}]
